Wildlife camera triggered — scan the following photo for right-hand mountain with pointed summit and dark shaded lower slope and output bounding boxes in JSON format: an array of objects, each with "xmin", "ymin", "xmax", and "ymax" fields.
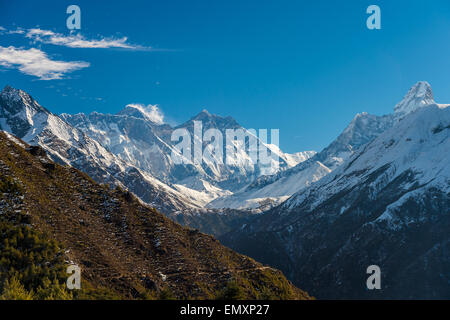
[{"xmin": 221, "ymin": 82, "xmax": 450, "ymax": 299}]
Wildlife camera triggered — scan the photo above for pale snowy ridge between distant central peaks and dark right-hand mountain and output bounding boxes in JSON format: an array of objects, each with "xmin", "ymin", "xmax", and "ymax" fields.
[{"xmin": 208, "ymin": 106, "xmax": 395, "ymax": 211}]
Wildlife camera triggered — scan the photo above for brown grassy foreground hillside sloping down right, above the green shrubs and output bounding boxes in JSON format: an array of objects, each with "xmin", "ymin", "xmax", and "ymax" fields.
[{"xmin": 0, "ymin": 131, "xmax": 309, "ymax": 299}]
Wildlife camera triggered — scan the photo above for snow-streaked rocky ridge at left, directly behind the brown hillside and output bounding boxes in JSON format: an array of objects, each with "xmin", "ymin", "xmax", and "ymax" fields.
[{"xmin": 0, "ymin": 86, "xmax": 198, "ymax": 212}]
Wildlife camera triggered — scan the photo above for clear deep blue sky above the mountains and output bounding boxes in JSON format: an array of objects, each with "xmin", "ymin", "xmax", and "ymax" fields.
[{"xmin": 0, "ymin": 0, "xmax": 450, "ymax": 152}]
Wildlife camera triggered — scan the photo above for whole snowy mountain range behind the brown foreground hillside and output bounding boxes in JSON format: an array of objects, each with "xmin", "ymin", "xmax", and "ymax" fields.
[{"xmin": 0, "ymin": 81, "xmax": 450, "ymax": 299}]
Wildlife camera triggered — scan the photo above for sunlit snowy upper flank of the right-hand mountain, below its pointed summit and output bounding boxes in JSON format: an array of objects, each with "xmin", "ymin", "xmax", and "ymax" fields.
[{"xmin": 283, "ymin": 104, "xmax": 450, "ymax": 210}]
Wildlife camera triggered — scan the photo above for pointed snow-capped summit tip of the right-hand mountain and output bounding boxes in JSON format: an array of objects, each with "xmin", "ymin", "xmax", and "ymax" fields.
[{"xmin": 394, "ymin": 81, "xmax": 435, "ymax": 115}]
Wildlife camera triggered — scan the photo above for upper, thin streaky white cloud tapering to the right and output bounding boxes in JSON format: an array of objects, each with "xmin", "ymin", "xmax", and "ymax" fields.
[{"xmin": 25, "ymin": 28, "xmax": 151, "ymax": 50}]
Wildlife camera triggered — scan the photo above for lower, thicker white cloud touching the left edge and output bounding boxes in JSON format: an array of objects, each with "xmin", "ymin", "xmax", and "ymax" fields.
[{"xmin": 0, "ymin": 46, "xmax": 90, "ymax": 80}]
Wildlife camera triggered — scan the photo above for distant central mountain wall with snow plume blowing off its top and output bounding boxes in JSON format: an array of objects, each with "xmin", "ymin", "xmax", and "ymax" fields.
[{"xmin": 61, "ymin": 105, "xmax": 313, "ymax": 206}]
